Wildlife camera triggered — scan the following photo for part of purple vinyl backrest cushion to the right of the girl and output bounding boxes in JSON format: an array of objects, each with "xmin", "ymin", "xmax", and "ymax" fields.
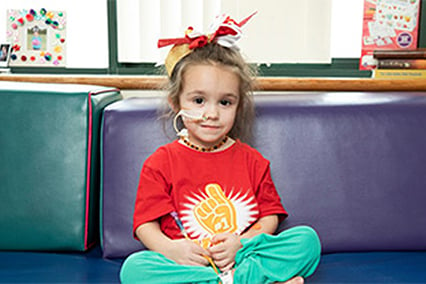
[{"xmin": 256, "ymin": 93, "xmax": 426, "ymax": 252}]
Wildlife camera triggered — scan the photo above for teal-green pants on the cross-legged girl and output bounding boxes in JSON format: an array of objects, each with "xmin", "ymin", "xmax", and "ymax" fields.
[{"xmin": 120, "ymin": 226, "xmax": 321, "ymax": 284}]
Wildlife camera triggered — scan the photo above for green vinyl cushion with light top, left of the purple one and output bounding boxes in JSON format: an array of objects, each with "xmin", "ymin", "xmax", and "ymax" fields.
[{"xmin": 0, "ymin": 82, "xmax": 121, "ymax": 251}]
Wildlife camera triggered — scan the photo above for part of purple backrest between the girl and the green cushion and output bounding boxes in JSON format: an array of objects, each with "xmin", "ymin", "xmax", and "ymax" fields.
[{"xmin": 100, "ymin": 98, "xmax": 169, "ymax": 258}]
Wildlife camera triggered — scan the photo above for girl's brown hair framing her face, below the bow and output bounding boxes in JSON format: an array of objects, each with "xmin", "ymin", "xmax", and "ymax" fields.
[{"xmin": 162, "ymin": 43, "xmax": 256, "ymax": 143}]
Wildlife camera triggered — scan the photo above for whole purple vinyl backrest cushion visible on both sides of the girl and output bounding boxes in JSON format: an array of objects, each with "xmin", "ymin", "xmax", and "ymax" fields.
[{"xmin": 101, "ymin": 93, "xmax": 426, "ymax": 258}]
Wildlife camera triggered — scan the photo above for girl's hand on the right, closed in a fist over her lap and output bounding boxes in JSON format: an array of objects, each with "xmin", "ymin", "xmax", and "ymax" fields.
[{"xmin": 209, "ymin": 233, "xmax": 243, "ymax": 272}]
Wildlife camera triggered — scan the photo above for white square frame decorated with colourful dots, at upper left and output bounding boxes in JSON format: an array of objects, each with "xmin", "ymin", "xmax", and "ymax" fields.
[{"xmin": 6, "ymin": 8, "xmax": 66, "ymax": 67}]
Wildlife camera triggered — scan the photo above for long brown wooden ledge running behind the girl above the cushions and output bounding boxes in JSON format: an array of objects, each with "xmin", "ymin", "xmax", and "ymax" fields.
[{"xmin": 0, "ymin": 74, "xmax": 426, "ymax": 92}]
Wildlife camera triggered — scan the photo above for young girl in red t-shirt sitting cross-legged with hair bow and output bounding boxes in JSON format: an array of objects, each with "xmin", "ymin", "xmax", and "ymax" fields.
[{"xmin": 120, "ymin": 13, "xmax": 321, "ymax": 283}]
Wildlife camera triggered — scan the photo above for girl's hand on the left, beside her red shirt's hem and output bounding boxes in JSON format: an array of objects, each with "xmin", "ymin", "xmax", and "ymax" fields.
[{"xmin": 164, "ymin": 239, "xmax": 210, "ymax": 266}]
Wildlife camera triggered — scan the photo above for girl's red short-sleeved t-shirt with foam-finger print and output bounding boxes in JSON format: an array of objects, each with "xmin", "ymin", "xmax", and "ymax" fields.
[{"xmin": 133, "ymin": 140, "xmax": 287, "ymax": 244}]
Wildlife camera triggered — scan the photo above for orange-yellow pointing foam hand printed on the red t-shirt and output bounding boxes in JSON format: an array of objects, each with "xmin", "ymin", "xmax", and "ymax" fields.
[{"xmin": 194, "ymin": 184, "xmax": 237, "ymax": 235}]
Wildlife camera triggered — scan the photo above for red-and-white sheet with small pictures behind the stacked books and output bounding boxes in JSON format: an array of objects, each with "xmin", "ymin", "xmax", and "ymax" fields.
[{"xmin": 360, "ymin": 0, "xmax": 421, "ymax": 70}]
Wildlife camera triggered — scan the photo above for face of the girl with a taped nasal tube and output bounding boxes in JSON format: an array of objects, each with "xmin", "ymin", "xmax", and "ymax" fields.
[{"xmin": 179, "ymin": 65, "xmax": 240, "ymax": 147}]
